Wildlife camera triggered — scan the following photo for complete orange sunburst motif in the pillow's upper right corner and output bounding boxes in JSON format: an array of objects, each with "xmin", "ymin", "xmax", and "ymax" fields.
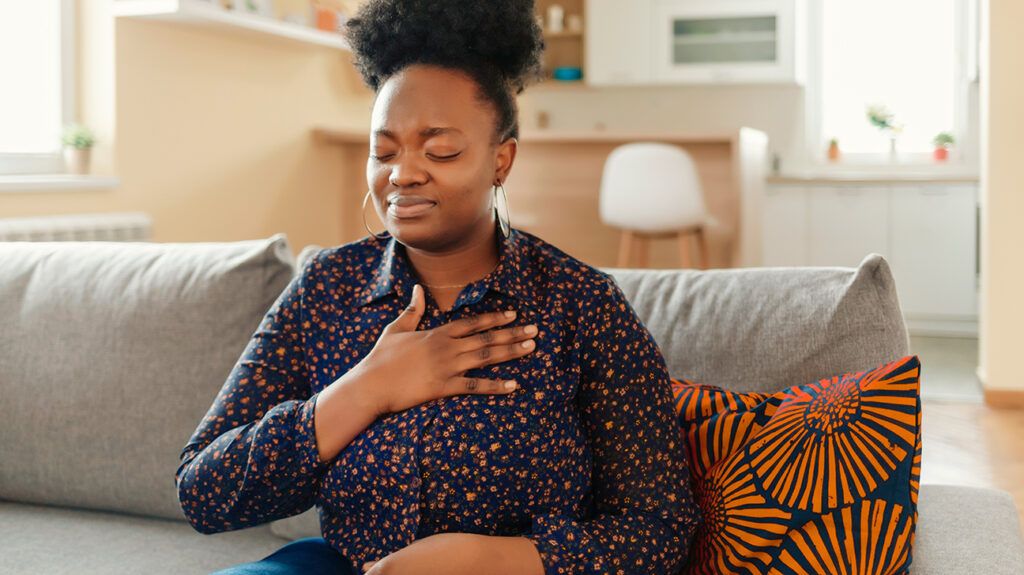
[{"xmin": 750, "ymin": 356, "xmax": 918, "ymax": 513}]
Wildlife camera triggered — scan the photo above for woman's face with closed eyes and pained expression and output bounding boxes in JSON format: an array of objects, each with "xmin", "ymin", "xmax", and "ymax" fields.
[{"xmin": 367, "ymin": 64, "xmax": 516, "ymax": 252}]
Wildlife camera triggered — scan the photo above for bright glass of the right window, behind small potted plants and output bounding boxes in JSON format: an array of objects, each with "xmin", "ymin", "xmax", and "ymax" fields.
[{"xmin": 808, "ymin": 0, "xmax": 974, "ymax": 164}]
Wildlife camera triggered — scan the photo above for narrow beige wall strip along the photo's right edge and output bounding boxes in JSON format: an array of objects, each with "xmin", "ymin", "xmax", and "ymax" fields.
[{"xmin": 979, "ymin": 0, "xmax": 1024, "ymax": 391}]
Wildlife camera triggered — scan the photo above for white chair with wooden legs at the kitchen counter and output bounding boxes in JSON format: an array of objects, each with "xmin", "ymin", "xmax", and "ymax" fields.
[{"xmin": 600, "ymin": 142, "xmax": 713, "ymax": 269}]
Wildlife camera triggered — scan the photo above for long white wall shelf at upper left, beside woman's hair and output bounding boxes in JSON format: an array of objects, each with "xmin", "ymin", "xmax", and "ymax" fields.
[{"xmin": 113, "ymin": 0, "xmax": 349, "ymax": 51}]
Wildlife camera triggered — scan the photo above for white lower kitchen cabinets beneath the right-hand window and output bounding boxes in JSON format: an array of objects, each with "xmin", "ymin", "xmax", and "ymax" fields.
[{"xmin": 761, "ymin": 183, "xmax": 978, "ymax": 335}]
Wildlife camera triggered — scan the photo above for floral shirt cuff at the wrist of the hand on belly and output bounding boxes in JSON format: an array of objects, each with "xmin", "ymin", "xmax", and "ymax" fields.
[{"xmin": 523, "ymin": 514, "xmax": 605, "ymax": 575}]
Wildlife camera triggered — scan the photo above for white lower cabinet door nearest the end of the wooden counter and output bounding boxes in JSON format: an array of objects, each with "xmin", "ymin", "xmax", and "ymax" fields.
[{"xmin": 761, "ymin": 185, "xmax": 808, "ymax": 266}]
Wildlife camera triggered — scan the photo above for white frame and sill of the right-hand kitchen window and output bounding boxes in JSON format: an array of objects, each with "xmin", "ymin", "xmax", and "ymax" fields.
[{"xmin": 802, "ymin": 0, "xmax": 979, "ymax": 173}]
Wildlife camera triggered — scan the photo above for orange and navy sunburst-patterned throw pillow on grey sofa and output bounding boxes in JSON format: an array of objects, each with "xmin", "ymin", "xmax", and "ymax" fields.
[{"xmin": 672, "ymin": 355, "xmax": 921, "ymax": 575}]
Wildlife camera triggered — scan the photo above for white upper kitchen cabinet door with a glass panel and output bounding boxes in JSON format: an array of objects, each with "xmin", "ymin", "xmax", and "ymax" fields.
[{"xmin": 651, "ymin": 0, "xmax": 803, "ymax": 83}]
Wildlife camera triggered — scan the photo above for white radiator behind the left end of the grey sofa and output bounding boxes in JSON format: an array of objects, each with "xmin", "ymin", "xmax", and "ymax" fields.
[{"xmin": 0, "ymin": 212, "xmax": 153, "ymax": 241}]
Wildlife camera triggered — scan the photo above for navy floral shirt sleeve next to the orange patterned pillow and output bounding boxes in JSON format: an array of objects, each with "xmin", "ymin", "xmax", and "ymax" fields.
[{"xmin": 524, "ymin": 272, "xmax": 701, "ymax": 575}]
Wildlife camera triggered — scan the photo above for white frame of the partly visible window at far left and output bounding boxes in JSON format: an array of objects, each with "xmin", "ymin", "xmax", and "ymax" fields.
[{"xmin": 0, "ymin": 0, "xmax": 78, "ymax": 176}]
